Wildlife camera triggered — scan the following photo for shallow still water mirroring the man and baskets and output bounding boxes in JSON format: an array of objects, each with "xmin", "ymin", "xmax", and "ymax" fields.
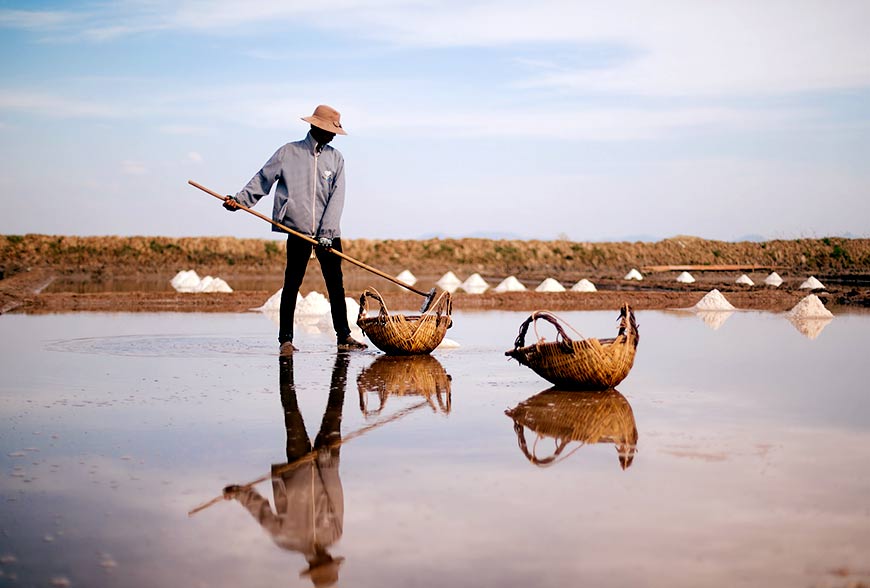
[{"xmin": 0, "ymin": 312, "xmax": 870, "ymax": 587}]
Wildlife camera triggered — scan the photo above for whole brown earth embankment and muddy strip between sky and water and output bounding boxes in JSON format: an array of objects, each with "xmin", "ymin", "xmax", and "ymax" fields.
[{"xmin": 0, "ymin": 235, "xmax": 870, "ymax": 312}]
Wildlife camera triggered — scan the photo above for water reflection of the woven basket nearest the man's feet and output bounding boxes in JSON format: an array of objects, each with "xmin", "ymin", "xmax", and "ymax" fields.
[{"xmin": 356, "ymin": 355, "xmax": 450, "ymax": 416}]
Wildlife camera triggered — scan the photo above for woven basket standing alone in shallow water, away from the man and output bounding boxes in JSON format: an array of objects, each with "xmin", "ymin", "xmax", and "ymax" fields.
[{"xmin": 505, "ymin": 304, "xmax": 640, "ymax": 390}]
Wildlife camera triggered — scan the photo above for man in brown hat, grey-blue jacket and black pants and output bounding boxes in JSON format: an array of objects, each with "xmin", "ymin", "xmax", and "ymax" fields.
[{"xmin": 224, "ymin": 104, "xmax": 367, "ymax": 355}]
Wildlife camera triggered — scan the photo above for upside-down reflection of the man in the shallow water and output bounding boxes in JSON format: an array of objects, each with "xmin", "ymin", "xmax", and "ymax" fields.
[{"xmin": 224, "ymin": 353, "xmax": 349, "ymax": 586}]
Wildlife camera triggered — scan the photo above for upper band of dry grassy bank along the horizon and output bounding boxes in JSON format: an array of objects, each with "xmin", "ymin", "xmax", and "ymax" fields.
[{"xmin": 0, "ymin": 235, "xmax": 870, "ymax": 279}]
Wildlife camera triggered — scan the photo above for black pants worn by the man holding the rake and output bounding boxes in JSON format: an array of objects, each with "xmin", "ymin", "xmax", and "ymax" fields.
[{"xmin": 278, "ymin": 235, "xmax": 350, "ymax": 343}]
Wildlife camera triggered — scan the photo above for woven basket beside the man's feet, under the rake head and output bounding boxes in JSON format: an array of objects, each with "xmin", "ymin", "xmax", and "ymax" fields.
[{"xmin": 356, "ymin": 288, "xmax": 453, "ymax": 355}]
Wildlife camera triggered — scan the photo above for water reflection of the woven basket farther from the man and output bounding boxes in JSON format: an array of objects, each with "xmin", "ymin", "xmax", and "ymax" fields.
[{"xmin": 505, "ymin": 389, "xmax": 637, "ymax": 469}]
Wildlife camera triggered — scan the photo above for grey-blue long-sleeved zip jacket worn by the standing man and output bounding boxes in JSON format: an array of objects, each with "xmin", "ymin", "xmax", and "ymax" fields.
[{"xmin": 235, "ymin": 133, "xmax": 344, "ymax": 239}]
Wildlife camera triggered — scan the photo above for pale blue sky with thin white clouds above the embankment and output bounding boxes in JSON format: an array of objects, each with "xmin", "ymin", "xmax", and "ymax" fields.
[{"xmin": 0, "ymin": 0, "xmax": 870, "ymax": 241}]
